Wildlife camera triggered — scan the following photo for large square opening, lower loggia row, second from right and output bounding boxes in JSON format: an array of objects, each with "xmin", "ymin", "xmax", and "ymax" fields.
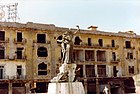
[{"xmin": 86, "ymin": 65, "xmax": 95, "ymax": 77}]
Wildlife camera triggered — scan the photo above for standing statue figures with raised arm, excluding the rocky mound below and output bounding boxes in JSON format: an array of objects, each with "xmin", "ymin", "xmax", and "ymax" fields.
[{"xmin": 57, "ymin": 25, "xmax": 79, "ymax": 63}]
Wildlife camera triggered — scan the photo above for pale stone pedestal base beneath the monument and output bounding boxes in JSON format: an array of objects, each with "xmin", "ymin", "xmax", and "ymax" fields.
[{"xmin": 48, "ymin": 82, "xmax": 85, "ymax": 94}]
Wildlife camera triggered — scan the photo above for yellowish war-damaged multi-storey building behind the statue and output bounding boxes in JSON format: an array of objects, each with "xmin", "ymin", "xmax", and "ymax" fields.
[{"xmin": 0, "ymin": 22, "xmax": 140, "ymax": 94}]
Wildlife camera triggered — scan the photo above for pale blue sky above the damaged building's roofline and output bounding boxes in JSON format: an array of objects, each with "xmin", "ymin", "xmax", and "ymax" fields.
[{"xmin": 0, "ymin": 0, "xmax": 140, "ymax": 34}]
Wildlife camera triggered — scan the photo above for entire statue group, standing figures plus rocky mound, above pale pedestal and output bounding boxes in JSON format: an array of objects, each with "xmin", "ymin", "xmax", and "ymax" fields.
[{"xmin": 51, "ymin": 26, "xmax": 79, "ymax": 82}]
